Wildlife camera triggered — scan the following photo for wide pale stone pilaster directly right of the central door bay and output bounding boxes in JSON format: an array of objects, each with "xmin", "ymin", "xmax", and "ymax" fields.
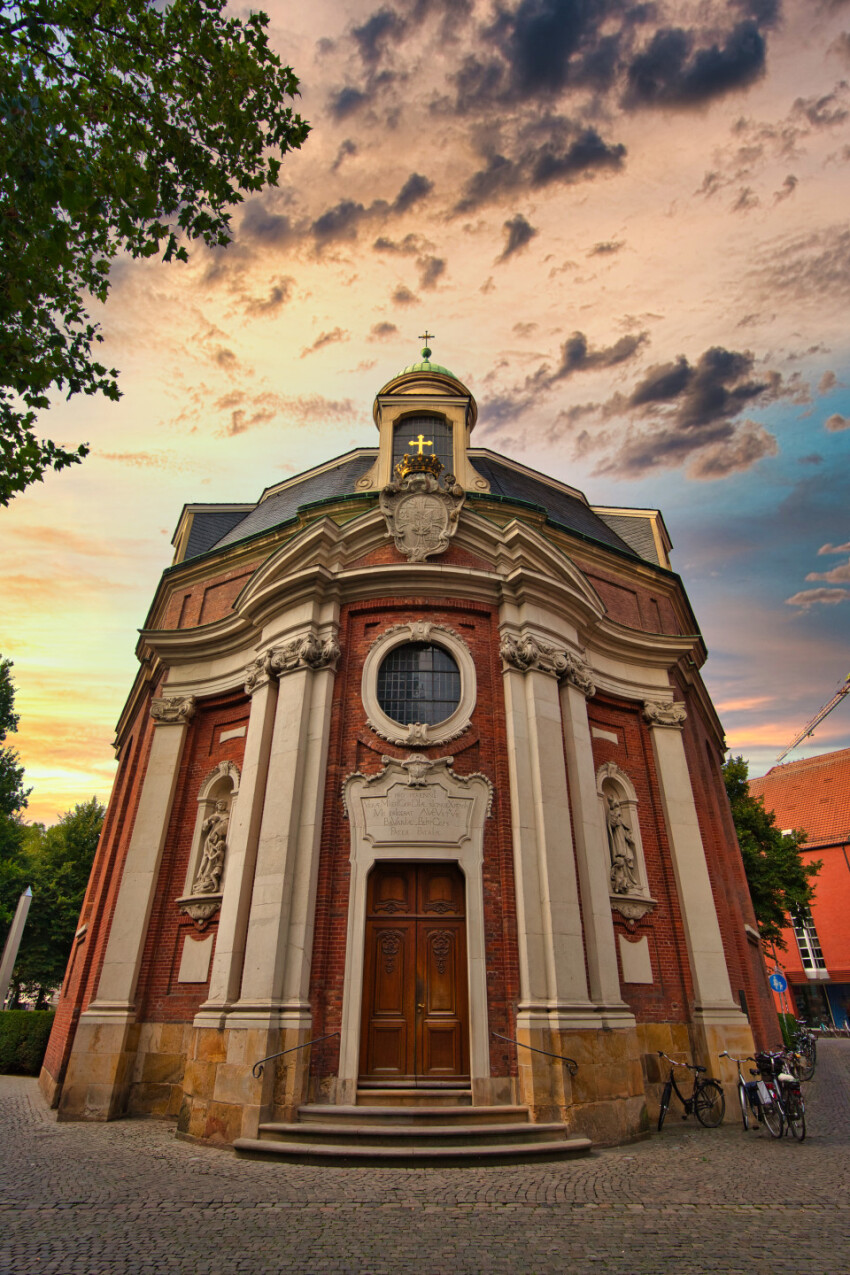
[{"xmin": 501, "ymin": 632, "xmax": 595, "ymax": 1028}]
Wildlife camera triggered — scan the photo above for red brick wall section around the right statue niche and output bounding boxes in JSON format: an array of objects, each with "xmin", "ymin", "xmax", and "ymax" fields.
[{"xmin": 587, "ymin": 694, "xmax": 693, "ymax": 1023}]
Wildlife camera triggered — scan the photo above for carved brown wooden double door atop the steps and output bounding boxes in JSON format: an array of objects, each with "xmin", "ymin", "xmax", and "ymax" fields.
[{"xmin": 361, "ymin": 863, "xmax": 469, "ymax": 1086}]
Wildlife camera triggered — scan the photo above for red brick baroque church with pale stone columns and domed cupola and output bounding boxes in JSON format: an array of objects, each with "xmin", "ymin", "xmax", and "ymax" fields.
[{"xmin": 42, "ymin": 349, "xmax": 776, "ymax": 1141}]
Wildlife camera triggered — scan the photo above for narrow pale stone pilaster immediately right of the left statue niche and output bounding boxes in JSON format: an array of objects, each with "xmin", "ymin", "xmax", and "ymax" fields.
[{"xmin": 195, "ymin": 660, "xmax": 278, "ymax": 1028}]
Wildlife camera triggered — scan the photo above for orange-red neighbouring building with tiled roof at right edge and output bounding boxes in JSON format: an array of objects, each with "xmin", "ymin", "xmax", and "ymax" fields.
[{"xmin": 749, "ymin": 748, "xmax": 850, "ymax": 1026}]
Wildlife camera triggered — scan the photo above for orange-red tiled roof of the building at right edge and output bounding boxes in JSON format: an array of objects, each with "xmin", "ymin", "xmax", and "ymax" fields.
[{"xmin": 749, "ymin": 748, "xmax": 850, "ymax": 848}]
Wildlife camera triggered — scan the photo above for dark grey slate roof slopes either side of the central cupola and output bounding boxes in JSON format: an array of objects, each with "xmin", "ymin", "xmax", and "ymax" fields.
[{"xmin": 184, "ymin": 448, "xmax": 658, "ymax": 562}]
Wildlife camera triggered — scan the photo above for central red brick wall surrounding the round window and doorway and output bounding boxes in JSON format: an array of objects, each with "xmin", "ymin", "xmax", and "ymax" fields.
[{"xmin": 311, "ymin": 596, "xmax": 519, "ymax": 1076}]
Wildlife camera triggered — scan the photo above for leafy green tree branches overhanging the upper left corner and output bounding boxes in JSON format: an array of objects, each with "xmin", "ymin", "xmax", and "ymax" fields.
[{"xmin": 0, "ymin": 0, "xmax": 308, "ymax": 505}]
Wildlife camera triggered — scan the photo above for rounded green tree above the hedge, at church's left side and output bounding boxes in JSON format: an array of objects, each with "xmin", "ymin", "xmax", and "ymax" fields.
[{"xmin": 6, "ymin": 797, "xmax": 104, "ymax": 1009}]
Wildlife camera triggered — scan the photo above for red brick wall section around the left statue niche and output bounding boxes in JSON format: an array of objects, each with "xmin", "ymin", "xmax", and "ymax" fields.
[{"xmin": 136, "ymin": 692, "xmax": 250, "ymax": 1023}]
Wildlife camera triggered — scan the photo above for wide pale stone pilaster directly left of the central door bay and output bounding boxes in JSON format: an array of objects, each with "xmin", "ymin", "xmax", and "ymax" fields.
[{"xmin": 228, "ymin": 634, "xmax": 339, "ymax": 1028}]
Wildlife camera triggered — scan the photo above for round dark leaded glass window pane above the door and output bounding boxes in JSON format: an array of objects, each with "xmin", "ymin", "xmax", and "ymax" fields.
[{"xmin": 377, "ymin": 643, "xmax": 460, "ymax": 725}]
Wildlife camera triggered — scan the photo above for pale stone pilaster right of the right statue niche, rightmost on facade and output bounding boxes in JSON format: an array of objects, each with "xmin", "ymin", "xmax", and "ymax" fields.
[{"xmin": 644, "ymin": 703, "xmax": 740, "ymax": 1015}]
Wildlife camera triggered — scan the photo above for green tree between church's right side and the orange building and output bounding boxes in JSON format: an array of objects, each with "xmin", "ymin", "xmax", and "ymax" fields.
[{"xmin": 723, "ymin": 757, "xmax": 821, "ymax": 949}]
